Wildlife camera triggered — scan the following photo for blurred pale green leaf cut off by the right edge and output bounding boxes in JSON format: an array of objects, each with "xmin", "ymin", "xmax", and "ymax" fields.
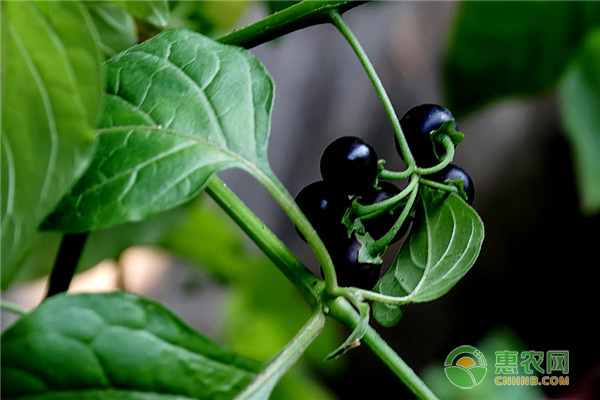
[{"xmin": 560, "ymin": 30, "xmax": 600, "ymax": 215}]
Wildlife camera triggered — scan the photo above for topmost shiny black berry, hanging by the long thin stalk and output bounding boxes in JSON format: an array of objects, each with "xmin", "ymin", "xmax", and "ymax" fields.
[{"xmin": 394, "ymin": 104, "xmax": 458, "ymax": 168}]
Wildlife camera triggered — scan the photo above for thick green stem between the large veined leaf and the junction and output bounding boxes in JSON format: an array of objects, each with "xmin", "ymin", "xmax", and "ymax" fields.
[{"xmin": 206, "ymin": 176, "xmax": 322, "ymax": 306}]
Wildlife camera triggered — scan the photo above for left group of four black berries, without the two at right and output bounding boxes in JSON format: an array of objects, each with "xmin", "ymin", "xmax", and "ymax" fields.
[{"xmin": 296, "ymin": 136, "xmax": 399, "ymax": 289}]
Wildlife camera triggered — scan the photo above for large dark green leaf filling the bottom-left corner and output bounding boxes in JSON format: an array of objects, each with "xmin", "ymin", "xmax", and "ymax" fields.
[{"xmin": 1, "ymin": 292, "xmax": 261, "ymax": 400}]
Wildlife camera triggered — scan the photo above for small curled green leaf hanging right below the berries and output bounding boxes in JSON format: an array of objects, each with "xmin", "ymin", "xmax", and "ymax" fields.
[{"xmin": 373, "ymin": 186, "xmax": 484, "ymax": 326}]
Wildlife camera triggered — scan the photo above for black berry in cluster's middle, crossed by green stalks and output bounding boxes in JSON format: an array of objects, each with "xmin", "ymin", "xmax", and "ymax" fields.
[{"xmin": 360, "ymin": 181, "xmax": 410, "ymax": 243}]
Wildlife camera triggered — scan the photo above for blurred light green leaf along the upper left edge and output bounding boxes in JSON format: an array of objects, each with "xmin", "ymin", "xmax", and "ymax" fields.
[{"xmin": 0, "ymin": 2, "xmax": 102, "ymax": 287}]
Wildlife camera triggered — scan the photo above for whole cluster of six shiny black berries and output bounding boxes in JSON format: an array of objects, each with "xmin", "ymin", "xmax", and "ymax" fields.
[{"xmin": 296, "ymin": 104, "xmax": 473, "ymax": 289}]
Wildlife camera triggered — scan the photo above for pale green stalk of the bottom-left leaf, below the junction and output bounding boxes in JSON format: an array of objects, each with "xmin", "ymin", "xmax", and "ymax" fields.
[{"xmin": 236, "ymin": 308, "xmax": 325, "ymax": 400}]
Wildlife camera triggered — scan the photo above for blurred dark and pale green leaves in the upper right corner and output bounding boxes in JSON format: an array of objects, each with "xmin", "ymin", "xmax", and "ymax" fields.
[{"xmin": 444, "ymin": 1, "xmax": 600, "ymax": 215}]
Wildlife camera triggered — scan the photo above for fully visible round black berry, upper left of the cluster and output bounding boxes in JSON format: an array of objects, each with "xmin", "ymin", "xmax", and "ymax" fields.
[{"xmin": 321, "ymin": 136, "xmax": 378, "ymax": 194}]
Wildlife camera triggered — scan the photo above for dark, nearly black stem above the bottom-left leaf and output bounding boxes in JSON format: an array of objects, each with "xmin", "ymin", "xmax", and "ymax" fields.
[{"xmin": 46, "ymin": 232, "xmax": 89, "ymax": 298}]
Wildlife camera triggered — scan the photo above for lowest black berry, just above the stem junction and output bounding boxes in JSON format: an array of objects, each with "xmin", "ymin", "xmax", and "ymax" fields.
[{"xmin": 329, "ymin": 237, "xmax": 381, "ymax": 290}]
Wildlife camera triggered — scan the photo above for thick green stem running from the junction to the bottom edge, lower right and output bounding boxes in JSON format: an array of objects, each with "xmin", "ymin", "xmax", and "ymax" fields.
[{"xmin": 327, "ymin": 297, "xmax": 437, "ymax": 400}]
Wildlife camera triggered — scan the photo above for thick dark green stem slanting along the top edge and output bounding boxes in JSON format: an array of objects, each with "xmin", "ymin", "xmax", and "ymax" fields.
[{"xmin": 217, "ymin": 1, "xmax": 366, "ymax": 49}]
